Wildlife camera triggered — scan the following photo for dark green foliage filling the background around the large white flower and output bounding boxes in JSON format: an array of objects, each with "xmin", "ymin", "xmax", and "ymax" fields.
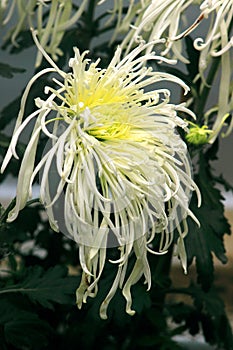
[{"xmin": 0, "ymin": 1, "xmax": 233, "ymax": 350}]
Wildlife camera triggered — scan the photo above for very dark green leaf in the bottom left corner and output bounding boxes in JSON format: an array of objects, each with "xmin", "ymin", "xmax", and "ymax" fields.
[{"xmin": 0, "ymin": 298, "xmax": 52, "ymax": 350}]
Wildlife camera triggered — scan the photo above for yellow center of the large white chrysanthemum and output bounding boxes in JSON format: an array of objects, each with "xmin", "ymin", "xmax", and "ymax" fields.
[{"xmin": 59, "ymin": 63, "xmax": 150, "ymax": 142}]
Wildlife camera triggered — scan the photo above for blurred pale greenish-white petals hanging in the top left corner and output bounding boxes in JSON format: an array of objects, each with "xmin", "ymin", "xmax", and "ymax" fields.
[{"xmin": 0, "ymin": 0, "xmax": 88, "ymax": 67}]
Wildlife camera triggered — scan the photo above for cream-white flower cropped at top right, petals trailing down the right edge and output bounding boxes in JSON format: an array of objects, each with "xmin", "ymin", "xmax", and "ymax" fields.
[{"xmin": 107, "ymin": 0, "xmax": 233, "ymax": 142}]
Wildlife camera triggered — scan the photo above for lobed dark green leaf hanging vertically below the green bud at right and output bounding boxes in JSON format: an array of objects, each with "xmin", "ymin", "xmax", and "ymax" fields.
[{"xmin": 185, "ymin": 152, "xmax": 231, "ymax": 290}]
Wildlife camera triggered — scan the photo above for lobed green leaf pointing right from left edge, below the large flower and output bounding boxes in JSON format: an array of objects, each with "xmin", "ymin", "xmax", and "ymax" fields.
[{"xmin": 0, "ymin": 265, "xmax": 79, "ymax": 309}]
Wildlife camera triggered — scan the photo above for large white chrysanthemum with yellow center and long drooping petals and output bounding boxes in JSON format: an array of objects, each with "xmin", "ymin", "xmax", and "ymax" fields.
[{"xmin": 1, "ymin": 34, "xmax": 200, "ymax": 318}]
